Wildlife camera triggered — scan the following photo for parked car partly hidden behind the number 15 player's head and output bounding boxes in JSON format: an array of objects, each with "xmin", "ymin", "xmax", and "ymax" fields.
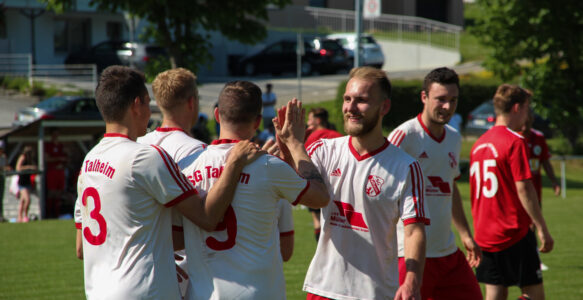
[{"xmin": 465, "ymin": 100, "xmax": 553, "ymax": 138}]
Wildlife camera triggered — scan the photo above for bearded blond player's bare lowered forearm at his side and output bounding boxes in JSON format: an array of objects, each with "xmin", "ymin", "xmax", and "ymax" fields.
[{"xmin": 395, "ymin": 223, "xmax": 425, "ymax": 300}]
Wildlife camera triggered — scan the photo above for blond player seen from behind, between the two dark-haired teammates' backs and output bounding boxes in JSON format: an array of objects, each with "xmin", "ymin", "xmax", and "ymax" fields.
[{"xmin": 137, "ymin": 68, "xmax": 207, "ymax": 297}]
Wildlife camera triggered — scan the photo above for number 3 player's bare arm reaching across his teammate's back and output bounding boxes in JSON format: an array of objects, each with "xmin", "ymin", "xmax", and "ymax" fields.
[{"xmin": 176, "ymin": 141, "xmax": 264, "ymax": 231}]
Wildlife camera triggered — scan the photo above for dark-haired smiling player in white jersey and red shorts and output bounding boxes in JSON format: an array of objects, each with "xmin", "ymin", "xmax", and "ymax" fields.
[{"xmin": 389, "ymin": 68, "xmax": 482, "ymax": 299}]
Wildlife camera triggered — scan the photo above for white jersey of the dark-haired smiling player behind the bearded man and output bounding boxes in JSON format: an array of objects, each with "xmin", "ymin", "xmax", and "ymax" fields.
[{"xmin": 389, "ymin": 115, "xmax": 462, "ymax": 257}]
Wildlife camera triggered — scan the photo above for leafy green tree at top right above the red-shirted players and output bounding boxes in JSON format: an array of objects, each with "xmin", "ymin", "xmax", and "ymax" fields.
[{"xmin": 471, "ymin": 0, "xmax": 583, "ymax": 149}]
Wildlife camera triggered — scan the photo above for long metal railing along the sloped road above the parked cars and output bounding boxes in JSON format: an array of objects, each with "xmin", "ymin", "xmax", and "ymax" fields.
[{"xmin": 269, "ymin": 6, "xmax": 462, "ymax": 51}]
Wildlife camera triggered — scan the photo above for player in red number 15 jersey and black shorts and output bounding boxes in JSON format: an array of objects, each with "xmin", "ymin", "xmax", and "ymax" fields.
[{"xmin": 470, "ymin": 84, "xmax": 554, "ymax": 300}]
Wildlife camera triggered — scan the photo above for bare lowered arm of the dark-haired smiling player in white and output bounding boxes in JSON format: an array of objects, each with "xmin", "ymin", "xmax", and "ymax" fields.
[{"xmin": 451, "ymin": 182, "xmax": 482, "ymax": 268}]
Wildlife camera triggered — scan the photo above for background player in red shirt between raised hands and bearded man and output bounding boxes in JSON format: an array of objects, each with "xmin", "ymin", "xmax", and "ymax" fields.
[{"xmin": 304, "ymin": 107, "xmax": 342, "ymax": 242}]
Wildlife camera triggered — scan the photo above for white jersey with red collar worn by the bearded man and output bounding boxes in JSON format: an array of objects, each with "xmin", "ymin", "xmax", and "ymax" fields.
[{"xmin": 304, "ymin": 136, "xmax": 429, "ymax": 299}]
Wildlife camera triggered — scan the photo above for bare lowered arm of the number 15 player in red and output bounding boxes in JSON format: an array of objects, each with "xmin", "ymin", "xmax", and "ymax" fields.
[{"xmin": 515, "ymin": 179, "xmax": 554, "ymax": 253}]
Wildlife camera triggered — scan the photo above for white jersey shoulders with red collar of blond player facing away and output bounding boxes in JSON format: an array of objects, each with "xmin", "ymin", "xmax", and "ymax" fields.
[{"xmin": 138, "ymin": 127, "xmax": 206, "ymax": 162}]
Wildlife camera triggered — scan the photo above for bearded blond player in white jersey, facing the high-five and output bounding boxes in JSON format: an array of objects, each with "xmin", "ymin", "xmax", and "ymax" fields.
[{"xmin": 304, "ymin": 67, "xmax": 429, "ymax": 299}]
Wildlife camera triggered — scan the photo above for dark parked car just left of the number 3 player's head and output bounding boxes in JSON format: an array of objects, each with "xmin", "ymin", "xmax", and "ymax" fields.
[{"xmin": 12, "ymin": 96, "xmax": 102, "ymax": 127}]
